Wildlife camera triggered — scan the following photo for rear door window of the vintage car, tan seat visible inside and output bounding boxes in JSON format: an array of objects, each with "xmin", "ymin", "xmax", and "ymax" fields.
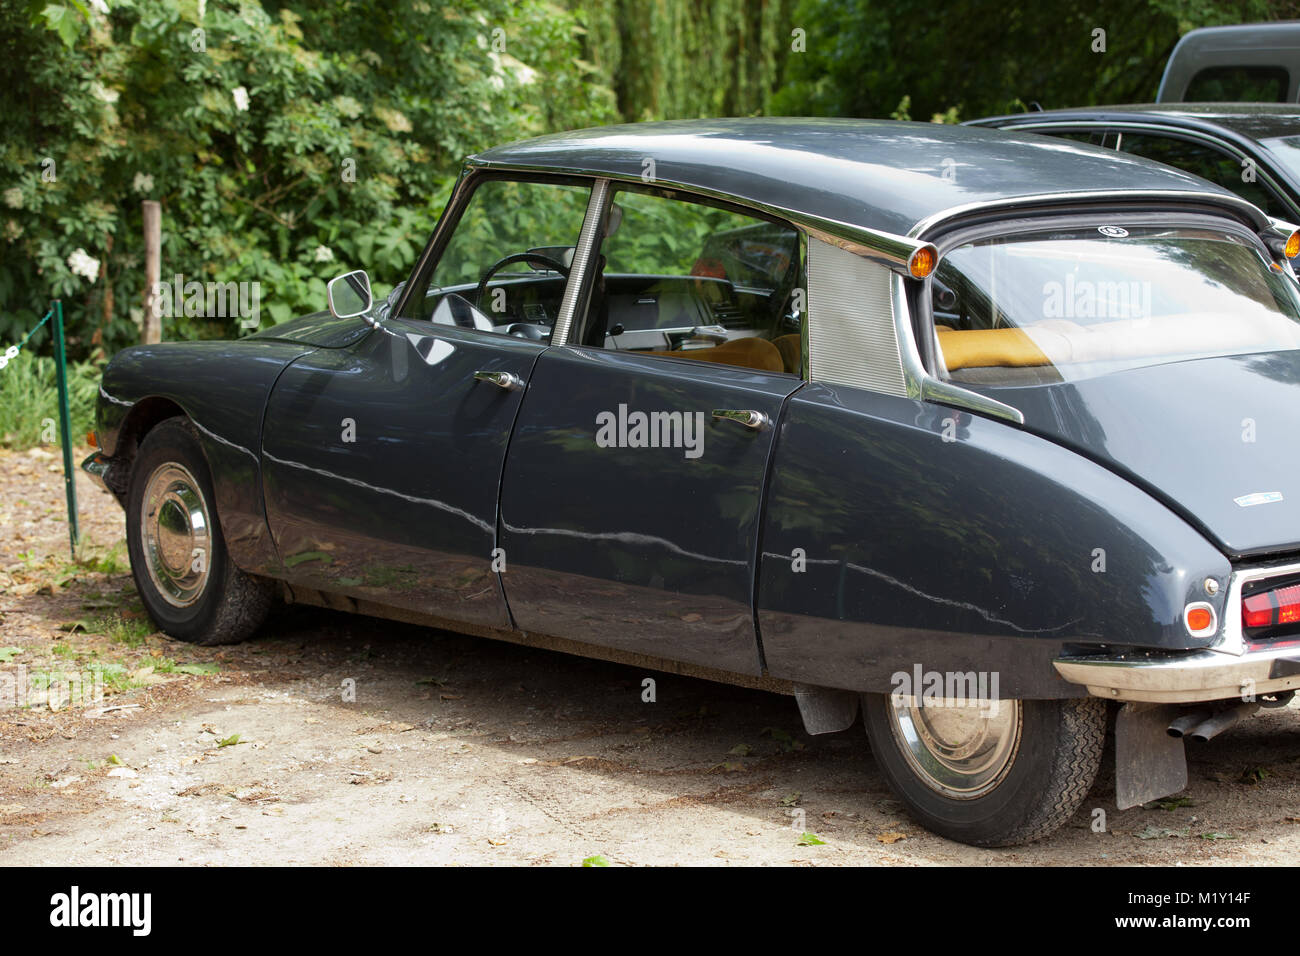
[{"xmin": 582, "ymin": 186, "xmax": 806, "ymax": 375}]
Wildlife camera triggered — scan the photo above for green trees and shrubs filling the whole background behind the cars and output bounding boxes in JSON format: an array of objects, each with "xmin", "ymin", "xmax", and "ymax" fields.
[{"xmin": 0, "ymin": 0, "xmax": 1300, "ymax": 366}]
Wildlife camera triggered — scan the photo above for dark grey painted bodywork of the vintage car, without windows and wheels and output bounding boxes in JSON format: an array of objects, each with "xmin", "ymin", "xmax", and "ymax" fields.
[{"xmin": 86, "ymin": 120, "xmax": 1300, "ymax": 697}]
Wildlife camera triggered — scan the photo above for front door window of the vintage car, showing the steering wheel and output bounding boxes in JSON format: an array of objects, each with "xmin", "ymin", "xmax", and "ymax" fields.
[{"xmin": 416, "ymin": 179, "xmax": 590, "ymax": 341}]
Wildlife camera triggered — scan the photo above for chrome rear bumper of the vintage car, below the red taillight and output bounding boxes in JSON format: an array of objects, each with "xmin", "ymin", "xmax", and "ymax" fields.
[{"xmin": 1052, "ymin": 644, "xmax": 1300, "ymax": 704}]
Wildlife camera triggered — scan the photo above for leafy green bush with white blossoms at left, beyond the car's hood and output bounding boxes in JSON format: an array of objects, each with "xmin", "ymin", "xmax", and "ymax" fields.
[{"xmin": 0, "ymin": 0, "xmax": 616, "ymax": 355}]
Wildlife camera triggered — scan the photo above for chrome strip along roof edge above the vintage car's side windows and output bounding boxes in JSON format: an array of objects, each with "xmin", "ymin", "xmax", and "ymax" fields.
[{"xmin": 465, "ymin": 156, "xmax": 937, "ymax": 274}]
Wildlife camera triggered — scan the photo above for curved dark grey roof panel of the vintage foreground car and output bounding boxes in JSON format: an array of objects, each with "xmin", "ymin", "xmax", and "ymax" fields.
[{"xmin": 468, "ymin": 117, "xmax": 1258, "ymax": 235}]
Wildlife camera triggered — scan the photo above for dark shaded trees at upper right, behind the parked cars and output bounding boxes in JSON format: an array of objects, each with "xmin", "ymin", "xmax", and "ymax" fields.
[{"xmin": 771, "ymin": 0, "xmax": 1294, "ymax": 122}]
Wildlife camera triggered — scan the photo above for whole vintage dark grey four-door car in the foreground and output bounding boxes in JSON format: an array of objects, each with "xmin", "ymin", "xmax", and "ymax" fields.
[{"xmin": 78, "ymin": 120, "xmax": 1300, "ymax": 845}]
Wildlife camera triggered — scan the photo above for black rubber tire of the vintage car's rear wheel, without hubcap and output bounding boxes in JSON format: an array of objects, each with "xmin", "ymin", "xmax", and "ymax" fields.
[{"xmin": 862, "ymin": 693, "xmax": 1106, "ymax": 847}]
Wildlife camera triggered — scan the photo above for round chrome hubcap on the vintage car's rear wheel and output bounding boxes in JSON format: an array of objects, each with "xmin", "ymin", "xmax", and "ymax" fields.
[{"xmin": 889, "ymin": 696, "xmax": 1022, "ymax": 800}]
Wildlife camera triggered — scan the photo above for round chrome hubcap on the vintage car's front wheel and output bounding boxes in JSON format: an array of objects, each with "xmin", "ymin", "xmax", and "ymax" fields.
[{"xmin": 140, "ymin": 462, "xmax": 212, "ymax": 607}]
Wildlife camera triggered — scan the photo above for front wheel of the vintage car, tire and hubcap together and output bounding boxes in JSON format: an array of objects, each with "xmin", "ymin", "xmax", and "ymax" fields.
[{"xmin": 126, "ymin": 418, "xmax": 274, "ymax": 645}]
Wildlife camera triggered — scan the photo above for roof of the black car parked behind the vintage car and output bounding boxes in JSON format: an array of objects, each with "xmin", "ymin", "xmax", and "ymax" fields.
[{"xmin": 970, "ymin": 103, "xmax": 1300, "ymax": 140}]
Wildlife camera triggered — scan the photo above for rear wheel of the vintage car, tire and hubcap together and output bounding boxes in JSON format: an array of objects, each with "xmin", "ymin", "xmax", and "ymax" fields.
[{"xmin": 862, "ymin": 693, "xmax": 1106, "ymax": 847}]
